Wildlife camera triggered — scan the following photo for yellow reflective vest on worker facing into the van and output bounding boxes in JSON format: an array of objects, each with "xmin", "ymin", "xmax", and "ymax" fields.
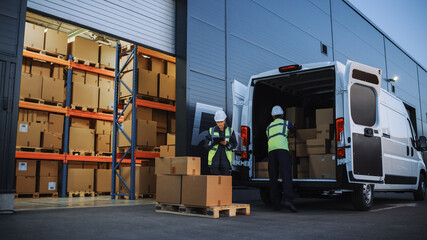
[{"xmin": 266, "ymin": 118, "xmax": 289, "ymax": 152}]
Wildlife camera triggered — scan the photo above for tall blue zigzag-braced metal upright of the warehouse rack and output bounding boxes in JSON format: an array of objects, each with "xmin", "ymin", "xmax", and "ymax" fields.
[{"xmin": 111, "ymin": 43, "xmax": 138, "ymax": 200}]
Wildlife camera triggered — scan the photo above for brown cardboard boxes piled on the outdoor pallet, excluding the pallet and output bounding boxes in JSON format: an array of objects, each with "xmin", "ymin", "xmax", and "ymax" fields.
[{"xmin": 156, "ymin": 157, "xmax": 232, "ymax": 207}]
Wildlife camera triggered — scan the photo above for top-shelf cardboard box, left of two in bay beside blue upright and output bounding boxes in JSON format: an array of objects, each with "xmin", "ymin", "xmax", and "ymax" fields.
[{"xmin": 68, "ymin": 37, "xmax": 99, "ymax": 63}]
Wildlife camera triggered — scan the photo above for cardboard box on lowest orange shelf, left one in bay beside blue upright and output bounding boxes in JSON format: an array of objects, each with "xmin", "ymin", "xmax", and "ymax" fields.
[{"xmin": 69, "ymin": 127, "xmax": 95, "ymax": 152}]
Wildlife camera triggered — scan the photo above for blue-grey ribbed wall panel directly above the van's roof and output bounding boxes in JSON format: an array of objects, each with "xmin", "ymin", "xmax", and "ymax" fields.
[{"xmin": 227, "ymin": 1, "xmax": 332, "ymax": 63}]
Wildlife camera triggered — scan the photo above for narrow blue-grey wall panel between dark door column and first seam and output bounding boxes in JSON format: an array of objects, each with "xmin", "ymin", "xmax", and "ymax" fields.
[{"xmin": 188, "ymin": 18, "xmax": 225, "ymax": 81}]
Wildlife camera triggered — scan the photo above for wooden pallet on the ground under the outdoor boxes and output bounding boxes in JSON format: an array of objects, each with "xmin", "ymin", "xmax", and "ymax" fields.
[{"xmin": 156, "ymin": 203, "xmax": 251, "ymax": 218}]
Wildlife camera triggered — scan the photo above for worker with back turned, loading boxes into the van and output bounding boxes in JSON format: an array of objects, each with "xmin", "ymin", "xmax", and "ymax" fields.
[{"xmin": 266, "ymin": 105, "xmax": 297, "ymax": 212}]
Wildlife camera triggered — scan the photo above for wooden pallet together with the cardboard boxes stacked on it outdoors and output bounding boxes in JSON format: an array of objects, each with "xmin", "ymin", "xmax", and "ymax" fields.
[{"xmin": 156, "ymin": 157, "xmax": 250, "ymax": 218}]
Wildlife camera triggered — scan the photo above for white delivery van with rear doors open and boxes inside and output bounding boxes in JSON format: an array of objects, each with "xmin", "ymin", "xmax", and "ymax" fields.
[{"xmin": 233, "ymin": 61, "xmax": 427, "ymax": 210}]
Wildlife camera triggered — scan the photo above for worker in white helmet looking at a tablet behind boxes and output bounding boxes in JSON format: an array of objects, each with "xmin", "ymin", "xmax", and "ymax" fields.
[{"xmin": 205, "ymin": 110, "xmax": 237, "ymax": 175}]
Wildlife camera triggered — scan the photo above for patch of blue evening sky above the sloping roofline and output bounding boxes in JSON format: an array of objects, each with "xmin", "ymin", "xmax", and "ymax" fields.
[{"xmin": 349, "ymin": 0, "xmax": 427, "ymax": 70}]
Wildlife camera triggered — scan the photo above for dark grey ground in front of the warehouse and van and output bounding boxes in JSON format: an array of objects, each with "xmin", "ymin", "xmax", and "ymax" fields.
[{"xmin": 0, "ymin": 194, "xmax": 427, "ymax": 240}]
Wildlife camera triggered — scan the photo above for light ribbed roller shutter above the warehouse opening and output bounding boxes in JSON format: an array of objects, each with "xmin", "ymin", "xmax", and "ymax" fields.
[{"xmin": 27, "ymin": 0, "xmax": 175, "ymax": 54}]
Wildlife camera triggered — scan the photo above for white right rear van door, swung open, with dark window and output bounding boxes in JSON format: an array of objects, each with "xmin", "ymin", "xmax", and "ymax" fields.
[{"xmin": 341, "ymin": 61, "xmax": 384, "ymax": 184}]
